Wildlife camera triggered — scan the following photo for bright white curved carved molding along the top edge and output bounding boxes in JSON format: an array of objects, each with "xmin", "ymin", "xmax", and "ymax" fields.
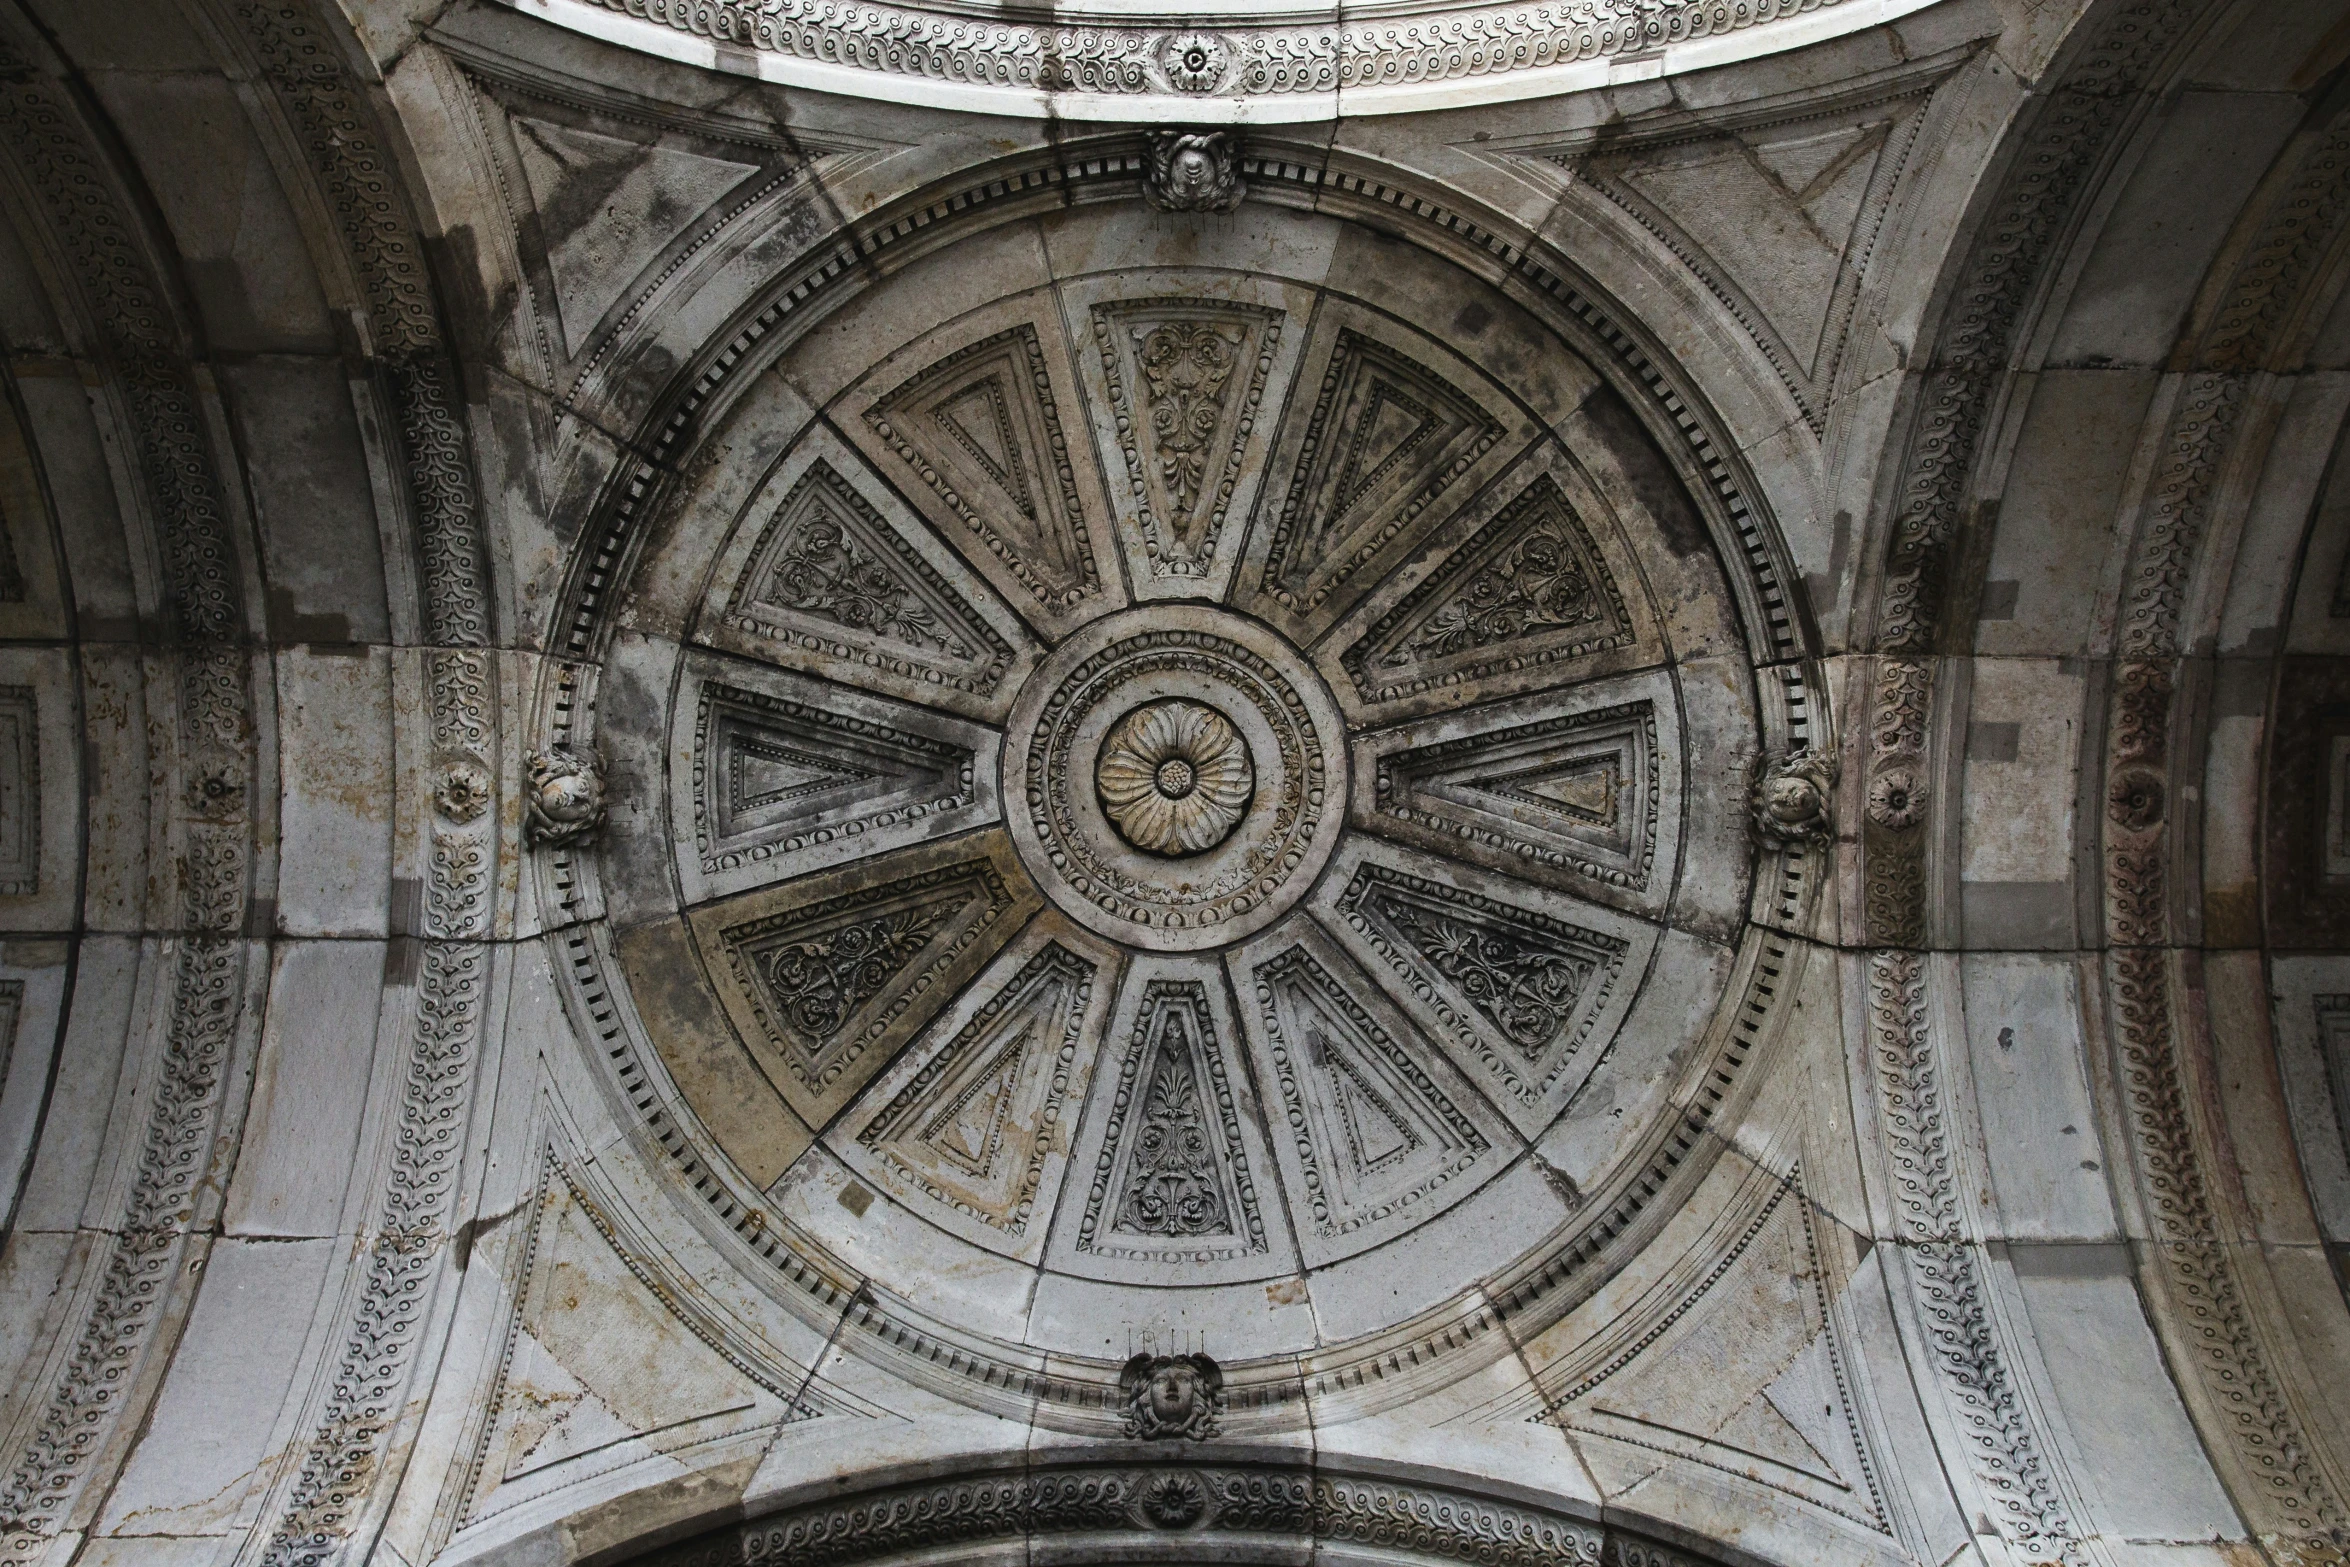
[{"xmin": 508, "ymin": 0, "xmax": 1941, "ymax": 125}]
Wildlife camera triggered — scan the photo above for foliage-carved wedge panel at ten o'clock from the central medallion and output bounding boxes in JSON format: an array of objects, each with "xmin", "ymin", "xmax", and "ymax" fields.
[{"xmin": 726, "ymin": 460, "xmax": 1013, "ymax": 695}]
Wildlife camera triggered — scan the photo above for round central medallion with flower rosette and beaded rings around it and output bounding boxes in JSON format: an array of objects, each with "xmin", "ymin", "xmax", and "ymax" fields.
[{"xmin": 1003, "ymin": 604, "xmax": 1347, "ymax": 951}]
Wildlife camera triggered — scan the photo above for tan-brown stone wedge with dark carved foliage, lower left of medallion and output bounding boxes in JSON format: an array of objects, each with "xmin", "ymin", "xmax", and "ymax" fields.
[{"xmin": 691, "ymin": 846, "xmax": 1036, "ymax": 1123}]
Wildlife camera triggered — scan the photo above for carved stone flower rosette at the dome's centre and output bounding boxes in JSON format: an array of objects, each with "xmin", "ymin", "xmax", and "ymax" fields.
[{"xmin": 1093, "ymin": 700, "xmax": 1257, "ymax": 855}]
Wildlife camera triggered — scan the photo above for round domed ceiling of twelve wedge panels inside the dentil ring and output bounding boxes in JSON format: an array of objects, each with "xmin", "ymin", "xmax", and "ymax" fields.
[{"xmin": 580, "ymin": 204, "xmax": 1800, "ymax": 1424}]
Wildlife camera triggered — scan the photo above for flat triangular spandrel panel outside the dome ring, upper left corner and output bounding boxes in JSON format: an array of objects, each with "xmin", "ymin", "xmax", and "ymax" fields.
[{"xmin": 510, "ymin": 113, "xmax": 759, "ymax": 355}]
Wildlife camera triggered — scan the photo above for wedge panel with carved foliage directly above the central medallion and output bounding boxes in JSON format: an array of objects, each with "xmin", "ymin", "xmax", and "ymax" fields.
[{"xmin": 1093, "ymin": 298, "xmax": 1281, "ymax": 578}]
